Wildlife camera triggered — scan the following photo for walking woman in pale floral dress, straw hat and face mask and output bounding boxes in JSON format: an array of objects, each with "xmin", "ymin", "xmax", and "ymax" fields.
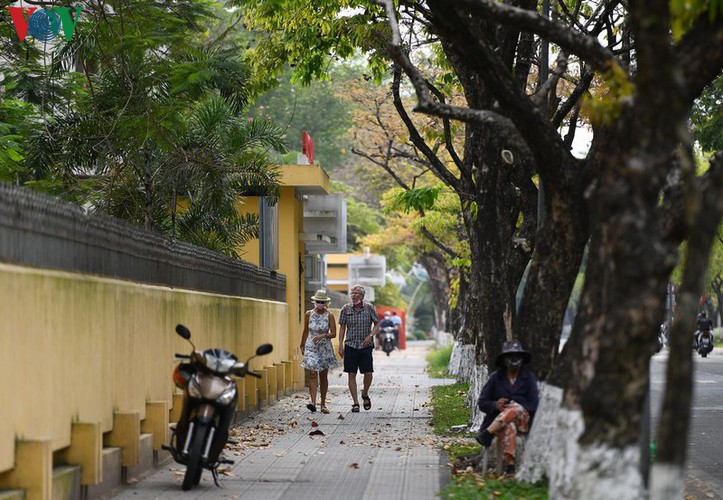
[{"xmin": 301, "ymin": 290, "xmax": 339, "ymax": 413}]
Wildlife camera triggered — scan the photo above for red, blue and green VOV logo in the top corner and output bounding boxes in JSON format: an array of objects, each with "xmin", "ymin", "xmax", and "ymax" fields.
[{"xmin": 7, "ymin": 7, "xmax": 83, "ymax": 42}]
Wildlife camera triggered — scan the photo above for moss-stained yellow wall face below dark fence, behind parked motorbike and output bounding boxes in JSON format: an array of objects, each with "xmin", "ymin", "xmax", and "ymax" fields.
[{"xmin": 0, "ymin": 264, "xmax": 288, "ymax": 476}]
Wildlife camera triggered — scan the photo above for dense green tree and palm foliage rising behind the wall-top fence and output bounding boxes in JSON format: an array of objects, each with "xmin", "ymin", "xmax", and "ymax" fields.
[{"xmin": 6, "ymin": 0, "xmax": 285, "ymax": 256}]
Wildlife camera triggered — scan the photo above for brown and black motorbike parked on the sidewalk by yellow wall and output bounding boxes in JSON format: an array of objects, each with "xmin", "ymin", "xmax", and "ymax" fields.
[{"xmin": 163, "ymin": 325, "xmax": 273, "ymax": 490}]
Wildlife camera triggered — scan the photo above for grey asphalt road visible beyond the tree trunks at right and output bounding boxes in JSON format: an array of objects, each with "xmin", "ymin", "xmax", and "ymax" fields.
[{"xmin": 650, "ymin": 348, "xmax": 723, "ymax": 499}]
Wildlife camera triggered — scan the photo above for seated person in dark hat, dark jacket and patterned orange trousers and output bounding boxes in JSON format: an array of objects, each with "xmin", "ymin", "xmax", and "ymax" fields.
[{"xmin": 476, "ymin": 340, "xmax": 539, "ymax": 476}]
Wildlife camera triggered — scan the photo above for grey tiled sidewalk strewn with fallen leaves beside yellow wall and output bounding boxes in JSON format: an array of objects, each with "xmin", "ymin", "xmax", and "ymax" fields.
[{"xmin": 113, "ymin": 342, "xmax": 453, "ymax": 500}]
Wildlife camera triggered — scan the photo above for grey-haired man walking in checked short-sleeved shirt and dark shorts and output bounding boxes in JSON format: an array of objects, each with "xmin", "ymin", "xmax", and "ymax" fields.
[{"xmin": 339, "ymin": 285, "xmax": 379, "ymax": 413}]
